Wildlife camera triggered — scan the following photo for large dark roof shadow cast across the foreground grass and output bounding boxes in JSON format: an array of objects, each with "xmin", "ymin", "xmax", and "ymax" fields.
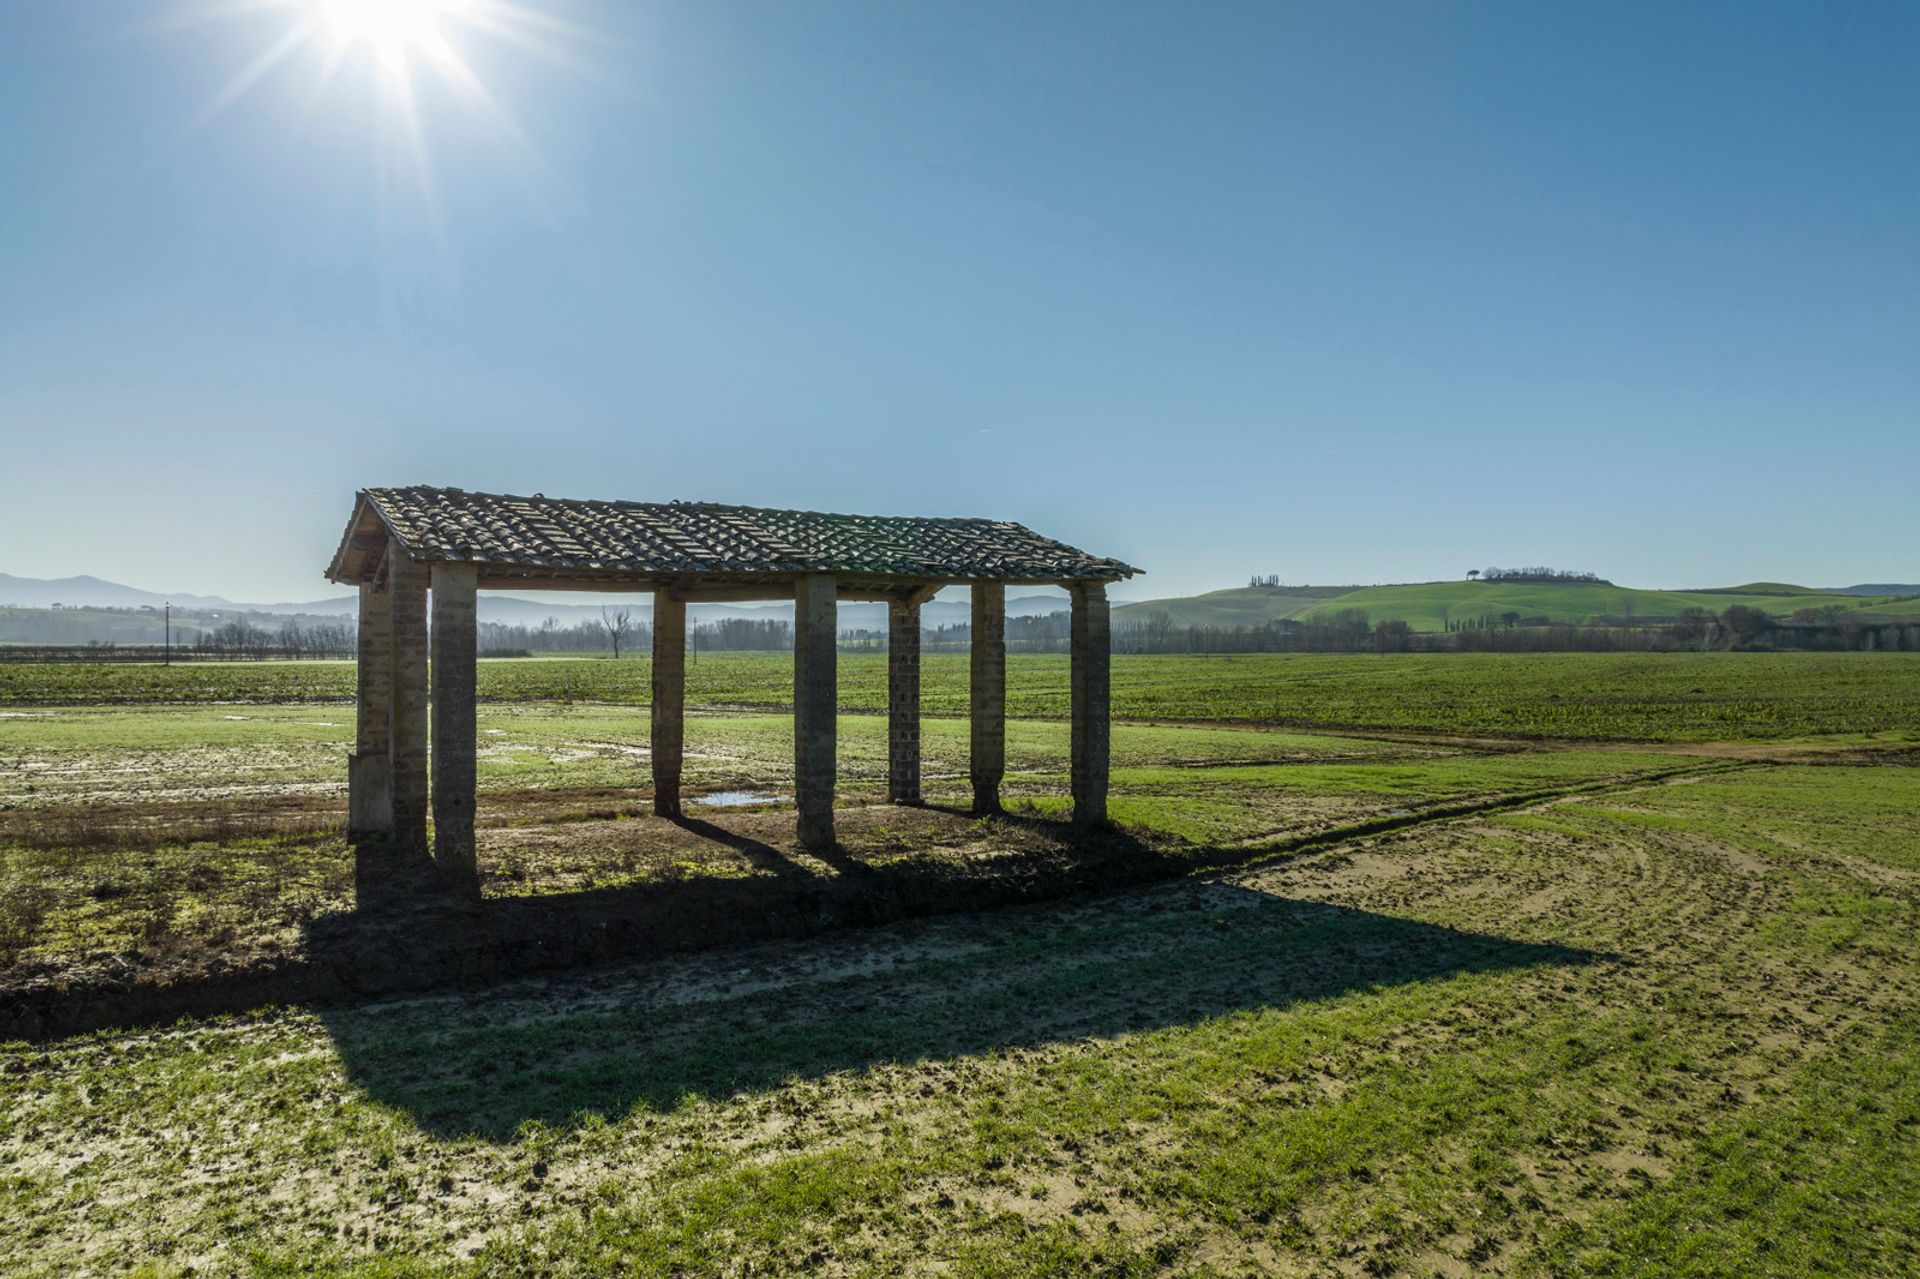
[{"xmin": 323, "ymin": 881, "xmax": 1599, "ymax": 1143}]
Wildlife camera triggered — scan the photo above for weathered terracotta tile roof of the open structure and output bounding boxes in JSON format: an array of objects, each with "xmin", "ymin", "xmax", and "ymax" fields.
[{"xmin": 328, "ymin": 486, "xmax": 1139, "ymax": 582}]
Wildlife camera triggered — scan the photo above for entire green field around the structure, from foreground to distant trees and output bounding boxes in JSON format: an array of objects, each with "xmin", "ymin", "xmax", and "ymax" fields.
[{"xmin": 0, "ymin": 655, "xmax": 1920, "ymax": 1279}]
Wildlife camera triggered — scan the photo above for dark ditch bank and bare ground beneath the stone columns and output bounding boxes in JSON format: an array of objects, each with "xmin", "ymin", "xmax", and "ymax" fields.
[{"xmin": 0, "ymin": 807, "xmax": 1190, "ymax": 1039}]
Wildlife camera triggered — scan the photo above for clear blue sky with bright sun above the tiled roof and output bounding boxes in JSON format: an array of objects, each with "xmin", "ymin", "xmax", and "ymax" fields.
[{"xmin": 0, "ymin": 0, "xmax": 1920, "ymax": 599}]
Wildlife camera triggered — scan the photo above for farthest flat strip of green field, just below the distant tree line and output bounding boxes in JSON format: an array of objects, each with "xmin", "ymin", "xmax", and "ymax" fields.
[{"xmin": 11, "ymin": 653, "xmax": 1920, "ymax": 741}]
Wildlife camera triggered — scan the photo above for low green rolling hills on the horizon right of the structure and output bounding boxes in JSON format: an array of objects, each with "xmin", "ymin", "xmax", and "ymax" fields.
[{"xmin": 1114, "ymin": 582, "xmax": 1920, "ymax": 630}]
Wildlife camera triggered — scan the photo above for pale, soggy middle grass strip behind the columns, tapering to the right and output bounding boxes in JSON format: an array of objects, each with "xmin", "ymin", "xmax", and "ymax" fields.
[{"xmin": 0, "ymin": 703, "xmax": 1705, "ymax": 968}]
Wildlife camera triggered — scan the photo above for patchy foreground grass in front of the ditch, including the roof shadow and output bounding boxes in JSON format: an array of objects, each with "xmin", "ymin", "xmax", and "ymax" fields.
[{"xmin": 0, "ymin": 764, "xmax": 1920, "ymax": 1279}]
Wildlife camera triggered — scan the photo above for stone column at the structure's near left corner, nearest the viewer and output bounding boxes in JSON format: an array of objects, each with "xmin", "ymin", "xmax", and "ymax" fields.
[{"xmin": 432, "ymin": 565, "xmax": 480, "ymax": 893}]
